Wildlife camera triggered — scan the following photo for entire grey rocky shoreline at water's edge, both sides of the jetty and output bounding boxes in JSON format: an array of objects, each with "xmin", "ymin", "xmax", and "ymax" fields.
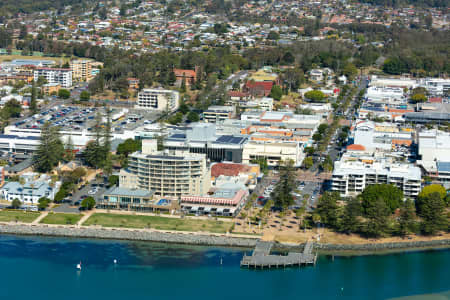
[{"xmin": 0, "ymin": 223, "xmax": 450, "ymax": 255}]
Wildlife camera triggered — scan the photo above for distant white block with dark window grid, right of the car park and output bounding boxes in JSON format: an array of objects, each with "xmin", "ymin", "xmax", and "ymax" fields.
[{"xmin": 136, "ymin": 89, "xmax": 180, "ymax": 111}]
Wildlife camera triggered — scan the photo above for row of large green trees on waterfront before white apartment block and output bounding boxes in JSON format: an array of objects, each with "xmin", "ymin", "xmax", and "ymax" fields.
[{"xmin": 317, "ymin": 184, "xmax": 449, "ymax": 237}]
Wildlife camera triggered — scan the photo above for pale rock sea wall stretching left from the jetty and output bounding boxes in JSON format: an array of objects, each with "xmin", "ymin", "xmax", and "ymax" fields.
[{"xmin": 0, "ymin": 224, "xmax": 258, "ymax": 248}]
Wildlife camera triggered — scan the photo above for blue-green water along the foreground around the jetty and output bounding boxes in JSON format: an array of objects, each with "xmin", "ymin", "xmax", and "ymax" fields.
[{"xmin": 0, "ymin": 236, "xmax": 450, "ymax": 300}]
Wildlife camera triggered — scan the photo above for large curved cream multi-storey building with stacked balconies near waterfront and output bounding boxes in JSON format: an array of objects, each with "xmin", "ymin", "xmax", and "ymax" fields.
[{"xmin": 119, "ymin": 140, "xmax": 211, "ymax": 198}]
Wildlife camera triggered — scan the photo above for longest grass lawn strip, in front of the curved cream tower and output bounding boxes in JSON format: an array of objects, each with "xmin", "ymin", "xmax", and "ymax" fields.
[{"xmin": 83, "ymin": 213, "xmax": 233, "ymax": 233}]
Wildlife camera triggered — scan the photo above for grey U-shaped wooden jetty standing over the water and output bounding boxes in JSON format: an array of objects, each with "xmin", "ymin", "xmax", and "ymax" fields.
[{"xmin": 241, "ymin": 241, "xmax": 317, "ymax": 269}]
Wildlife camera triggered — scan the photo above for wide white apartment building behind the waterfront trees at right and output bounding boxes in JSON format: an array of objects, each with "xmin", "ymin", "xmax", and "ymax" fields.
[{"xmin": 331, "ymin": 155, "xmax": 421, "ymax": 198}]
